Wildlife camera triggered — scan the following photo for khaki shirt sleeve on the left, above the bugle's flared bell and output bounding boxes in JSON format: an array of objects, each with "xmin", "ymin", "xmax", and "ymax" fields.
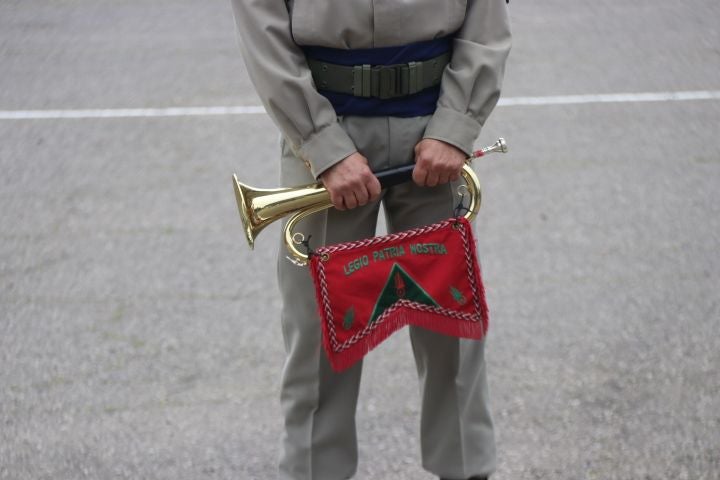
[{"xmin": 232, "ymin": 0, "xmax": 357, "ymax": 178}]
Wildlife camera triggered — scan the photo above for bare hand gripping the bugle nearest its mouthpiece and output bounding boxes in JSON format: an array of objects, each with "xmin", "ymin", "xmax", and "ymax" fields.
[{"xmin": 413, "ymin": 138, "xmax": 467, "ymax": 187}]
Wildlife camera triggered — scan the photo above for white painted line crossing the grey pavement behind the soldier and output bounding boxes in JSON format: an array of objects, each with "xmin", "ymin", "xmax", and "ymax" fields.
[{"xmin": 0, "ymin": 90, "xmax": 720, "ymax": 120}]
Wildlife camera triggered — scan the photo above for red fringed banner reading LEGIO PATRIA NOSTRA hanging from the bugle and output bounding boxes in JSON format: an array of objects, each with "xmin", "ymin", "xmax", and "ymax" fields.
[{"xmin": 310, "ymin": 218, "xmax": 488, "ymax": 371}]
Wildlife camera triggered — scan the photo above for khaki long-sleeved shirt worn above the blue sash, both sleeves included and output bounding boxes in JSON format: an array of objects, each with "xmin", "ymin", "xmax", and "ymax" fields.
[{"xmin": 232, "ymin": 0, "xmax": 510, "ymax": 178}]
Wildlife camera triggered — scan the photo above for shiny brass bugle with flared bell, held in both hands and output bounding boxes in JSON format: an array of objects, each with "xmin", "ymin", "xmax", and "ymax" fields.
[{"xmin": 233, "ymin": 138, "xmax": 507, "ymax": 264}]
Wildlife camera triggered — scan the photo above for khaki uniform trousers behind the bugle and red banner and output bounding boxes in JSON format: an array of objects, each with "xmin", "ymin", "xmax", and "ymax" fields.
[{"xmin": 278, "ymin": 116, "xmax": 495, "ymax": 480}]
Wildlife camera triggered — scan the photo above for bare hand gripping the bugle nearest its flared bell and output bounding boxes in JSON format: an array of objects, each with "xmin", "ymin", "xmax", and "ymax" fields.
[{"xmin": 320, "ymin": 152, "xmax": 381, "ymax": 210}]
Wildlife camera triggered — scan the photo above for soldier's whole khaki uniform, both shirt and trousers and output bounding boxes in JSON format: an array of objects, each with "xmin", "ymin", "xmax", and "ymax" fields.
[{"xmin": 232, "ymin": 0, "xmax": 510, "ymax": 480}]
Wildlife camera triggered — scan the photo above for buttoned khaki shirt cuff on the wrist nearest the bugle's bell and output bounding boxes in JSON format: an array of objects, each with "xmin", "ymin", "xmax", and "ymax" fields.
[{"xmin": 295, "ymin": 122, "xmax": 357, "ymax": 178}]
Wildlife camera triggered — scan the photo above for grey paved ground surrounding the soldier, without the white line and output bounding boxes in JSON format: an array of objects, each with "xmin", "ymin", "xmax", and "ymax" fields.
[{"xmin": 0, "ymin": 0, "xmax": 720, "ymax": 480}]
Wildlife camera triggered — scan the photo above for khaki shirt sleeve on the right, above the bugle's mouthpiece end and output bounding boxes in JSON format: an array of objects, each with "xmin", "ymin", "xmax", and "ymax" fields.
[{"xmin": 424, "ymin": 0, "xmax": 511, "ymax": 155}]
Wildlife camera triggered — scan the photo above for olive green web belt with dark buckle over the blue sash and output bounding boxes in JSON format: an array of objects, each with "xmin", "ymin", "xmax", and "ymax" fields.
[{"xmin": 307, "ymin": 52, "xmax": 450, "ymax": 100}]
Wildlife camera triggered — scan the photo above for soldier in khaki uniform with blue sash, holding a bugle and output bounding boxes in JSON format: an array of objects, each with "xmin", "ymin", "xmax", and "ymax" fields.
[{"xmin": 232, "ymin": 0, "xmax": 510, "ymax": 480}]
